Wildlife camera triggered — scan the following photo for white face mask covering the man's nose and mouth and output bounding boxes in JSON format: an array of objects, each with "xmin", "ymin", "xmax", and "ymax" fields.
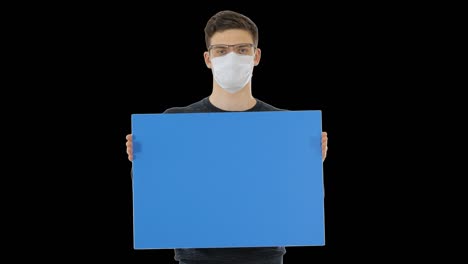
[{"xmin": 211, "ymin": 52, "xmax": 254, "ymax": 93}]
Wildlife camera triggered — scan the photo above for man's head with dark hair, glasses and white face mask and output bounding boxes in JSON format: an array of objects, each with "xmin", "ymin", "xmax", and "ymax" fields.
[{"xmin": 203, "ymin": 10, "xmax": 261, "ymax": 93}]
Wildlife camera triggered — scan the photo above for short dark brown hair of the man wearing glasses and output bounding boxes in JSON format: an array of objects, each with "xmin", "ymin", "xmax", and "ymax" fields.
[{"xmin": 205, "ymin": 10, "xmax": 258, "ymax": 49}]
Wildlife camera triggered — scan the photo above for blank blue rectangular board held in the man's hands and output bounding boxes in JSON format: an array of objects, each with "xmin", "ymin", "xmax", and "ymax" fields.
[{"xmin": 131, "ymin": 110, "xmax": 325, "ymax": 249}]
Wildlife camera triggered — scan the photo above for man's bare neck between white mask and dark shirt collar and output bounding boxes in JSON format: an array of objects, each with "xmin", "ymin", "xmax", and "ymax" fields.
[{"xmin": 209, "ymin": 84, "xmax": 257, "ymax": 111}]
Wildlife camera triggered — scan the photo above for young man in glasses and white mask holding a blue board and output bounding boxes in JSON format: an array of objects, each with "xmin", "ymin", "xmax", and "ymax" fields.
[{"xmin": 126, "ymin": 11, "xmax": 328, "ymax": 264}]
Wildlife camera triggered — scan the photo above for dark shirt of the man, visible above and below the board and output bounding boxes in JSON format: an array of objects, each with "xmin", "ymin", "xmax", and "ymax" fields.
[{"xmin": 164, "ymin": 97, "xmax": 286, "ymax": 263}]
